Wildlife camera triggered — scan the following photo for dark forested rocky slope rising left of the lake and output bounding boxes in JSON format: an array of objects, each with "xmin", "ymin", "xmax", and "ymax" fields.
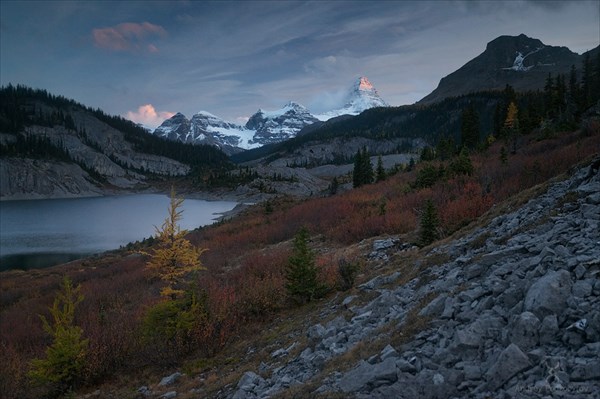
[{"xmin": 0, "ymin": 86, "xmax": 228, "ymax": 198}]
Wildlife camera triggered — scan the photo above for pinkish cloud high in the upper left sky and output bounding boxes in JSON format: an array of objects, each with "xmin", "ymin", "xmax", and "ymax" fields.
[{"xmin": 92, "ymin": 22, "xmax": 167, "ymax": 53}]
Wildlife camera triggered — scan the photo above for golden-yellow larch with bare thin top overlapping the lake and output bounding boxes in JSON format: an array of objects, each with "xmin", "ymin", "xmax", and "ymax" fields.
[{"xmin": 146, "ymin": 189, "xmax": 206, "ymax": 299}]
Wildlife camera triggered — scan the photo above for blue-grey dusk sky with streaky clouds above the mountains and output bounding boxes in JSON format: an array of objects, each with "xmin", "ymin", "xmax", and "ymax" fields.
[{"xmin": 0, "ymin": 0, "xmax": 600, "ymax": 127}]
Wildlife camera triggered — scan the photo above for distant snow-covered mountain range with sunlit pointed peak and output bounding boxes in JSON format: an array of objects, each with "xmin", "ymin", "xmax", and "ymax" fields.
[{"xmin": 153, "ymin": 77, "xmax": 388, "ymax": 155}]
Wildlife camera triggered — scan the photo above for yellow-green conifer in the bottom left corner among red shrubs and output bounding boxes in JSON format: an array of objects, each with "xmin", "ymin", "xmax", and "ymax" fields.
[{"xmin": 29, "ymin": 276, "xmax": 88, "ymax": 391}]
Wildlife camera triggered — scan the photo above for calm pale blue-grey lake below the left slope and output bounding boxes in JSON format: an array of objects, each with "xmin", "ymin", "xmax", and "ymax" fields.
[{"xmin": 0, "ymin": 194, "xmax": 236, "ymax": 270}]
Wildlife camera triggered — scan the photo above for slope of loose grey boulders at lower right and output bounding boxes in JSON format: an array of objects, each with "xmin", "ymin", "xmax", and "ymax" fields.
[{"xmin": 227, "ymin": 159, "xmax": 600, "ymax": 399}]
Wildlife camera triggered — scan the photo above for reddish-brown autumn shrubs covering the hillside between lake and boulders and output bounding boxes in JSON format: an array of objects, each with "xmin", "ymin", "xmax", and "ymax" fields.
[{"xmin": 0, "ymin": 104, "xmax": 600, "ymax": 398}]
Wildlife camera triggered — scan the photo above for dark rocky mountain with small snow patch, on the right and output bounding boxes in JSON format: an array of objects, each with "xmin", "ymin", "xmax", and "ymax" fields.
[{"xmin": 419, "ymin": 34, "xmax": 582, "ymax": 104}]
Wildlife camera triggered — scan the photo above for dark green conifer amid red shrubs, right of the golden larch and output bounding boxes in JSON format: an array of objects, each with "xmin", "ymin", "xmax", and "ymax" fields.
[{"xmin": 285, "ymin": 227, "xmax": 327, "ymax": 304}]
